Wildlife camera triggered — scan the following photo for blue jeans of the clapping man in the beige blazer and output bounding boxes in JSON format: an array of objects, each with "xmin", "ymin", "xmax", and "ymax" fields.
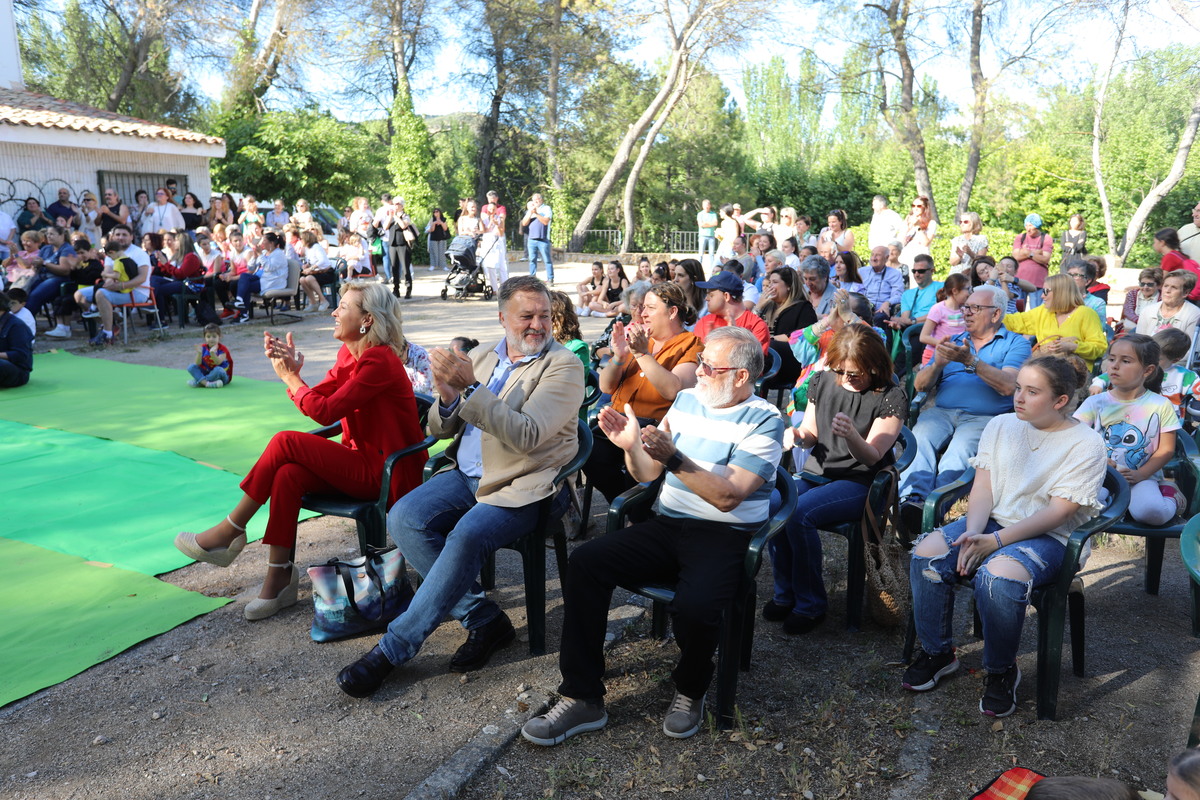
[{"xmin": 379, "ymin": 469, "xmax": 566, "ymax": 664}]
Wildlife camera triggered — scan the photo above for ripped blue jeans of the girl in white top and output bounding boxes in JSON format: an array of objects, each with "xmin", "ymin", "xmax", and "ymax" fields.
[{"xmin": 908, "ymin": 517, "xmax": 1067, "ymax": 673}]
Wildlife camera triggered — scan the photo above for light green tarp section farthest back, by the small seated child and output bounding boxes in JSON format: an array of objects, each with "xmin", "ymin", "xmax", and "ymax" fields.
[{"xmin": 0, "ymin": 353, "xmax": 317, "ymax": 474}]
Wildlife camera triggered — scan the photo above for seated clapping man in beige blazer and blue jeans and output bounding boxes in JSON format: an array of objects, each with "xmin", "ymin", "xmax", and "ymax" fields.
[{"xmin": 337, "ymin": 276, "xmax": 583, "ymax": 697}]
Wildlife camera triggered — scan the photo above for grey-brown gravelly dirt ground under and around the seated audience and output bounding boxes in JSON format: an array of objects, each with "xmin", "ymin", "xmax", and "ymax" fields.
[{"xmin": 0, "ymin": 265, "xmax": 1200, "ymax": 800}]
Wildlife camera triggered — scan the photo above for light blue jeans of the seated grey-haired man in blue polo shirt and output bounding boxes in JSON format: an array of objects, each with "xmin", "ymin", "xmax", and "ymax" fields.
[{"xmin": 900, "ymin": 405, "xmax": 992, "ymax": 499}]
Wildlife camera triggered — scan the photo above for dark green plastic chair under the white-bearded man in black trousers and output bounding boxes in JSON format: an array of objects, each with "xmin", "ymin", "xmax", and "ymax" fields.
[{"xmin": 608, "ymin": 467, "xmax": 796, "ymax": 729}]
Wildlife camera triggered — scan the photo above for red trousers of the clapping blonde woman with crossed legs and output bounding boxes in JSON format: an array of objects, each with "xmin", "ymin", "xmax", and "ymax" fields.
[{"xmin": 241, "ymin": 431, "xmax": 383, "ymax": 547}]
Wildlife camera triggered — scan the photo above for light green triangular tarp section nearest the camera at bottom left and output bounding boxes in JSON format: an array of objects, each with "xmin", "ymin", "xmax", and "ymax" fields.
[{"xmin": 0, "ymin": 539, "xmax": 229, "ymax": 705}]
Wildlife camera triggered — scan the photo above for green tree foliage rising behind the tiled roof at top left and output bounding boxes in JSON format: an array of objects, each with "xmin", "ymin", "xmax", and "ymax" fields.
[{"xmin": 17, "ymin": 0, "xmax": 205, "ymax": 127}]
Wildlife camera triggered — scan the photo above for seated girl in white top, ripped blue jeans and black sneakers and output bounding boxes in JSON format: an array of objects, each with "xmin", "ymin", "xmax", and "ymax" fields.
[{"xmin": 904, "ymin": 356, "xmax": 1108, "ymax": 717}]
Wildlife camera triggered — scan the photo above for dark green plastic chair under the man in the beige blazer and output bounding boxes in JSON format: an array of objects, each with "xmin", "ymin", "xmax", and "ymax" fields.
[{"xmin": 425, "ymin": 420, "xmax": 592, "ymax": 656}]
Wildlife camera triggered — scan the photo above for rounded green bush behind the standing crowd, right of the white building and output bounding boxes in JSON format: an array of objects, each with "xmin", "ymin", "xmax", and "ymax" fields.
[{"xmin": 212, "ymin": 109, "xmax": 388, "ymax": 207}]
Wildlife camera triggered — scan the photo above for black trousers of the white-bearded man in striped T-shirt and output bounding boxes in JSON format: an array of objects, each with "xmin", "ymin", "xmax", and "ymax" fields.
[{"xmin": 558, "ymin": 516, "xmax": 750, "ymax": 700}]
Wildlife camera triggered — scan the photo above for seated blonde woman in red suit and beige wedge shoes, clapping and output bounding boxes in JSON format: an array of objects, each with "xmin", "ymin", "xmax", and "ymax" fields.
[{"xmin": 175, "ymin": 282, "xmax": 425, "ymax": 620}]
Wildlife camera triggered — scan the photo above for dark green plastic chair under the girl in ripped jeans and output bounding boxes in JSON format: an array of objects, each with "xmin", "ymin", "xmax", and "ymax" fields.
[{"xmin": 904, "ymin": 467, "xmax": 1129, "ymax": 720}]
